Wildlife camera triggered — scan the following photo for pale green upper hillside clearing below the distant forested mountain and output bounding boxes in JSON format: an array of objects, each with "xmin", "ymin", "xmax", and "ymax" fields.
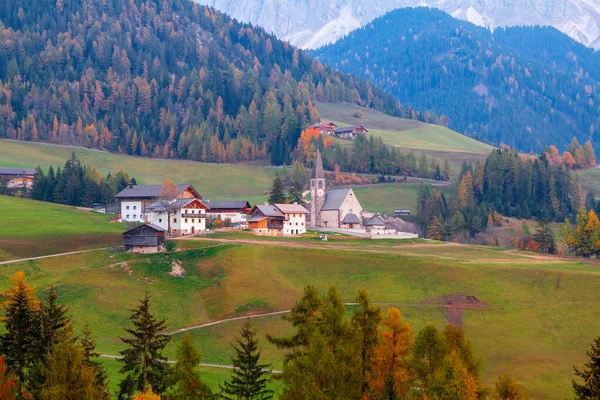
[{"xmin": 317, "ymin": 103, "xmax": 492, "ymax": 171}]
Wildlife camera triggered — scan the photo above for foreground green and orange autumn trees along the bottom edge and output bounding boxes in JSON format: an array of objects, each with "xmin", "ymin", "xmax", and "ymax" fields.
[{"xmin": 0, "ymin": 272, "xmax": 600, "ymax": 400}]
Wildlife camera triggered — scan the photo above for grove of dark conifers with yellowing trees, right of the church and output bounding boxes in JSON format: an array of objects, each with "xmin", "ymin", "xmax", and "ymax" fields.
[{"xmin": 417, "ymin": 148, "xmax": 581, "ymax": 244}]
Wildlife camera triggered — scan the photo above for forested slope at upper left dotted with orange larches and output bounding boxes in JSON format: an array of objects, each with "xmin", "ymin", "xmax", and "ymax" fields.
[{"xmin": 0, "ymin": 0, "xmax": 402, "ymax": 164}]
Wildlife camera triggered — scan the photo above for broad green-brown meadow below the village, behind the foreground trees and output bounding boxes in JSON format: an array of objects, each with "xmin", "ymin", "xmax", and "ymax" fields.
[{"xmin": 0, "ymin": 237, "xmax": 600, "ymax": 399}]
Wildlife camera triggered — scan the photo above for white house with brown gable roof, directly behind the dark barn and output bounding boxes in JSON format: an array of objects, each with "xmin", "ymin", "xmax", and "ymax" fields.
[{"xmin": 147, "ymin": 199, "xmax": 208, "ymax": 235}]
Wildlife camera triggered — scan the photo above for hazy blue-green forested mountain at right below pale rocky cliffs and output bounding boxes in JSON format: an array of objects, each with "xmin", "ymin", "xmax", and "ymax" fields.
[{"xmin": 314, "ymin": 8, "xmax": 600, "ymax": 152}]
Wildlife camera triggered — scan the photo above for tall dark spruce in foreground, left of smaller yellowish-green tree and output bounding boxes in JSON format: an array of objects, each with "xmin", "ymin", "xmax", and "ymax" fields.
[{"xmin": 119, "ymin": 295, "xmax": 171, "ymax": 397}]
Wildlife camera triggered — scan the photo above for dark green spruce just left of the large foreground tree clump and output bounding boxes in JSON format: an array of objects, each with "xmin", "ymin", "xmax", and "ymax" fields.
[{"xmin": 221, "ymin": 320, "xmax": 273, "ymax": 400}]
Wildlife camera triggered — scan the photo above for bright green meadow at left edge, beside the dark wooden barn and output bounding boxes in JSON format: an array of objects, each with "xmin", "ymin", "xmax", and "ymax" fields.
[{"xmin": 0, "ymin": 196, "xmax": 124, "ymax": 261}]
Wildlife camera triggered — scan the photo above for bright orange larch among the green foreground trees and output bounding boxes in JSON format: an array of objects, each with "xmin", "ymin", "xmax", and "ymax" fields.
[{"xmin": 370, "ymin": 308, "xmax": 414, "ymax": 399}]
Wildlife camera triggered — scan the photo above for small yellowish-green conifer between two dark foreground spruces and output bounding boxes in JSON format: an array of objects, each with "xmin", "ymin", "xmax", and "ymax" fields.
[{"xmin": 170, "ymin": 333, "xmax": 212, "ymax": 400}]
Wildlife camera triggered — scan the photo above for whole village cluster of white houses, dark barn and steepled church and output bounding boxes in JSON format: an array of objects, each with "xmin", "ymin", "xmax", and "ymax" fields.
[{"xmin": 116, "ymin": 151, "xmax": 416, "ymax": 252}]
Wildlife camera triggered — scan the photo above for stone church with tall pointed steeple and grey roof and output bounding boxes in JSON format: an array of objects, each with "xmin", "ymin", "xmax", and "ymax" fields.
[{"xmin": 310, "ymin": 150, "xmax": 363, "ymax": 229}]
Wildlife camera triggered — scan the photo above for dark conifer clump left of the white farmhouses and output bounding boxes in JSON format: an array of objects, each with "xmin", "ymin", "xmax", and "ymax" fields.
[{"xmin": 29, "ymin": 153, "xmax": 136, "ymax": 207}]
